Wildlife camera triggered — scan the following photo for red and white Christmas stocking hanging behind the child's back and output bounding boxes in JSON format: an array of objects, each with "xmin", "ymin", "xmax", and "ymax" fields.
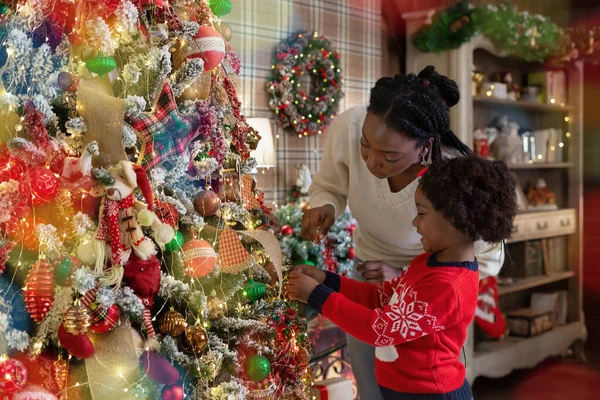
[{"xmin": 475, "ymin": 276, "xmax": 506, "ymax": 339}]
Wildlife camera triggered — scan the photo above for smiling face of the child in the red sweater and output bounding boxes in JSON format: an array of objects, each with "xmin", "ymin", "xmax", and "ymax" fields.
[{"xmin": 413, "ymin": 185, "xmax": 464, "ymax": 253}]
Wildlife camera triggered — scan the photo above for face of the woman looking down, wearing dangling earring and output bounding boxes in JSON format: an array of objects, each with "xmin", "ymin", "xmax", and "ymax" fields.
[{"xmin": 360, "ymin": 109, "xmax": 432, "ymax": 179}]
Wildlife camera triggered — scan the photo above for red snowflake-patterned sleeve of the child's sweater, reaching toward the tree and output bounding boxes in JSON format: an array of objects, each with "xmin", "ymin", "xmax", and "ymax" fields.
[{"xmin": 322, "ymin": 278, "xmax": 460, "ymax": 347}]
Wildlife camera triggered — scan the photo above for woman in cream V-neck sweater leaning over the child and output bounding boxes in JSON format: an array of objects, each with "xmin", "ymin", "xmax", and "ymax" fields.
[{"xmin": 302, "ymin": 66, "xmax": 504, "ymax": 400}]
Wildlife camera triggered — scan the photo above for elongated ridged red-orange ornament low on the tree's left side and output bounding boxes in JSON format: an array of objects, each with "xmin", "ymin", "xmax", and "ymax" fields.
[{"xmin": 24, "ymin": 260, "xmax": 54, "ymax": 322}]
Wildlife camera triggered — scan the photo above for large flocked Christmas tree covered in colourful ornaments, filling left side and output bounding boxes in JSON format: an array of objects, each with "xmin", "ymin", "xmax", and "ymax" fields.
[{"xmin": 0, "ymin": 0, "xmax": 310, "ymax": 399}]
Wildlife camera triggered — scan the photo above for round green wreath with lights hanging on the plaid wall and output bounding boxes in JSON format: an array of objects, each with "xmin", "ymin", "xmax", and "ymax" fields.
[{"xmin": 266, "ymin": 32, "xmax": 344, "ymax": 137}]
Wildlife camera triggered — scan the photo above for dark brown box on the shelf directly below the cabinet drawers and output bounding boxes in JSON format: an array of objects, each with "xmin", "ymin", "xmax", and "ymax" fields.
[{"xmin": 500, "ymin": 240, "xmax": 544, "ymax": 278}]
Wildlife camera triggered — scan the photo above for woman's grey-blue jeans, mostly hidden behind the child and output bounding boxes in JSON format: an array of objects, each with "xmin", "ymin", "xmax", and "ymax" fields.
[{"xmin": 346, "ymin": 259, "xmax": 383, "ymax": 400}]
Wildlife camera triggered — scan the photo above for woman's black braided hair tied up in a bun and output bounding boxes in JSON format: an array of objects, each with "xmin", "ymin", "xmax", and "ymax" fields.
[{"xmin": 368, "ymin": 66, "xmax": 472, "ymax": 161}]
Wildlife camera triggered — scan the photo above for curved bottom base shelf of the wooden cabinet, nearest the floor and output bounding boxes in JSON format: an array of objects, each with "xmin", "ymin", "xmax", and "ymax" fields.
[{"xmin": 467, "ymin": 321, "xmax": 587, "ymax": 383}]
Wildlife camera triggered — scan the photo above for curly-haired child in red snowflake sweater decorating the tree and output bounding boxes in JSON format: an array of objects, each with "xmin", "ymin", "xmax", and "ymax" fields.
[{"xmin": 288, "ymin": 156, "xmax": 517, "ymax": 400}]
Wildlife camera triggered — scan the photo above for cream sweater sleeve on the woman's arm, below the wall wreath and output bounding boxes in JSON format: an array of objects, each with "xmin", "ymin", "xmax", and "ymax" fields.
[{"xmin": 308, "ymin": 109, "xmax": 355, "ymax": 218}]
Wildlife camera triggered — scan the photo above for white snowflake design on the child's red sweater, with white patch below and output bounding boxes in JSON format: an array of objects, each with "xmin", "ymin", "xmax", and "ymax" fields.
[{"xmin": 373, "ymin": 283, "xmax": 444, "ymax": 362}]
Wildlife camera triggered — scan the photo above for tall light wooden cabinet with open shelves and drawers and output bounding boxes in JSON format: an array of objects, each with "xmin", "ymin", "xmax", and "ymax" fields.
[{"xmin": 403, "ymin": 11, "xmax": 587, "ymax": 382}]
